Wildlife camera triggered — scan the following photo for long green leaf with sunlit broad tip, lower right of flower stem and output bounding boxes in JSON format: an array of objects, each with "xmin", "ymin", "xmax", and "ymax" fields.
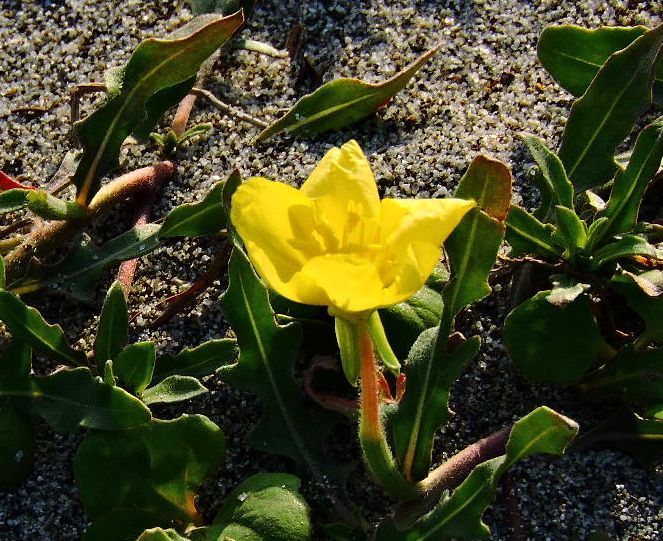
[{"xmin": 375, "ymin": 406, "xmax": 578, "ymax": 541}]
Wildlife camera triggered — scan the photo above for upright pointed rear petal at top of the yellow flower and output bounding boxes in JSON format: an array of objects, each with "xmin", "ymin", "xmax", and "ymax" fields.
[{"xmin": 301, "ymin": 140, "xmax": 380, "ymax": 245}]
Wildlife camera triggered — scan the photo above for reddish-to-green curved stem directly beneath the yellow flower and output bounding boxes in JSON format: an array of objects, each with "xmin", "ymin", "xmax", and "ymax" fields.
[{"xmin": 359, "ymin": 322, "xmax": 419, "ymax": 500}]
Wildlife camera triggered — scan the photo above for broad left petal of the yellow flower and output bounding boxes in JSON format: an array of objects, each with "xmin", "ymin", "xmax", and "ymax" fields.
[{"xmin": 230, "ymin": 177, "xmax": 318, "ymax": 296}]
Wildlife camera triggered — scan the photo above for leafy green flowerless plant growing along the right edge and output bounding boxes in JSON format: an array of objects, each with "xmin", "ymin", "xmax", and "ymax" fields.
[{"xmin": 504, "ymin": 21, "xmax": 663, "ymax": 457}]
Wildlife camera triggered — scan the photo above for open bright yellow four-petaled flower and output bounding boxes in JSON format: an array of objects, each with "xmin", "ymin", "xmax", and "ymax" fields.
[{"xmin": 230, "ymin": 141, "xmax": 475, "ymax": 317}]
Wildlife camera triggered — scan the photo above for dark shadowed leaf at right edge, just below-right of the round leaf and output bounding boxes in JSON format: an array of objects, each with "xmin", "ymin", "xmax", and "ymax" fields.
[{"xmin": 579, "ymin": 345, "xmax": 663, "ymax": 405}]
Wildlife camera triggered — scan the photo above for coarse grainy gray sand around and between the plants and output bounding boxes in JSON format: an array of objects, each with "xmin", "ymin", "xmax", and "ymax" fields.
[{"xmin": 0, "ymin": 0, "xmax": 663, "ymax": 541}]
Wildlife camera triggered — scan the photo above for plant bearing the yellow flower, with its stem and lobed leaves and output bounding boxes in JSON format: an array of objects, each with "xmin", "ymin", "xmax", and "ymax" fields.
[{"xmin": 226, "ymin": 141, "xmax": 577, "ymax": 539}]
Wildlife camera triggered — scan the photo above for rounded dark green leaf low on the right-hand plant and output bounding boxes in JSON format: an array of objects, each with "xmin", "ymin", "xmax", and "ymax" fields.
[{"xmin": 503, "ymin": 291, "xmax": 603, "ymax": 385}]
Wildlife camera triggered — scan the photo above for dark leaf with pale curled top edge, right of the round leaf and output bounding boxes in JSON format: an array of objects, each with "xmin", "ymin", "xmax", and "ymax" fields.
[{"xmin": 610, "ymin": 270, "xmax": 663, "ymax": 342}]
